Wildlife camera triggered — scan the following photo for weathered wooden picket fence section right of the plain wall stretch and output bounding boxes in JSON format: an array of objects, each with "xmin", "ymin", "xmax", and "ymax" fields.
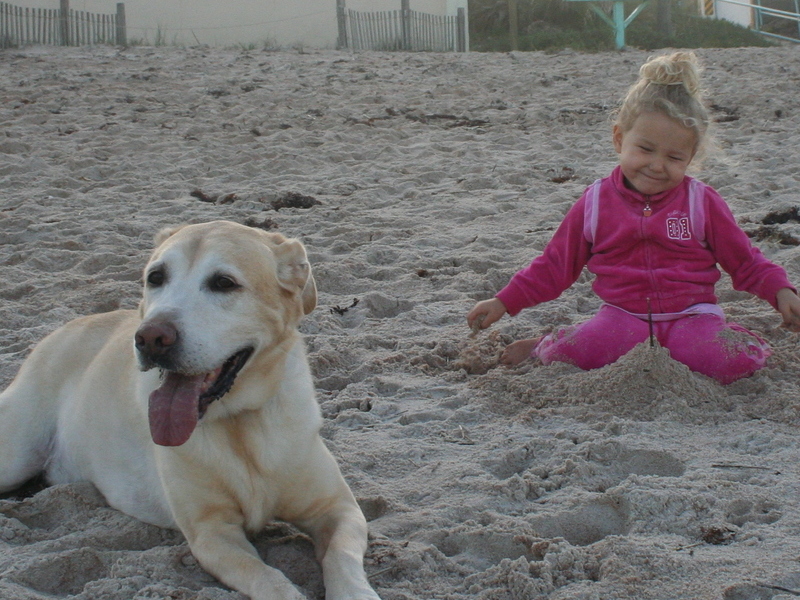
[{"xmin": 337, "ymin": 0, "xmax": 467, "ymax": 52}]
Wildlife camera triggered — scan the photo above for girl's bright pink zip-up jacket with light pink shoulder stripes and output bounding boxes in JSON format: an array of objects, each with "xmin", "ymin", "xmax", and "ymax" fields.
[{"xmin": 497, "ymin": 167, "xmax": 794, "ymax": 315}]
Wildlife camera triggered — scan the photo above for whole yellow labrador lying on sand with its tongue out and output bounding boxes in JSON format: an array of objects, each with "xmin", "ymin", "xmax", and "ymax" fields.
[{"xmin": 0, "ymin": 221, "xmax": 378, "ymax": 600}]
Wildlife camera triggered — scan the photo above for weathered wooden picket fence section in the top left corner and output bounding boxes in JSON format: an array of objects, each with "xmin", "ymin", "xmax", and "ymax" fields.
[{"xmin": 0, "ymin": 0, "xmax": 127, "ymax": 48}]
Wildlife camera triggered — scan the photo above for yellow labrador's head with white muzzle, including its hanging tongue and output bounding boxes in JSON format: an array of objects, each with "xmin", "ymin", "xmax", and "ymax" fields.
[{"xmin": 134, "ymin": 221, "xmax": 317, "ymax": 446}]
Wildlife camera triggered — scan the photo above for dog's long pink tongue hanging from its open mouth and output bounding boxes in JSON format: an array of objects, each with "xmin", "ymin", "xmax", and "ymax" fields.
[{"xmin": 149, "ymin": 373, "xmax": 205, "ymax": 446}]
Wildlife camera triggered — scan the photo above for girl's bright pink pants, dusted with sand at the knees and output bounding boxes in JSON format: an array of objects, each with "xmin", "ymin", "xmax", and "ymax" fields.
[{"xmin": 531, "ymin": 305, "xmax": 772, "ymax": 384}]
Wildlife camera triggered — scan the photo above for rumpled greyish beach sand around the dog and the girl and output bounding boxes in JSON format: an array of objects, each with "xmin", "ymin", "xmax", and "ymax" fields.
[{"xmin": 0, "ymin": 46, "xmax": 800, "ymax": 600}]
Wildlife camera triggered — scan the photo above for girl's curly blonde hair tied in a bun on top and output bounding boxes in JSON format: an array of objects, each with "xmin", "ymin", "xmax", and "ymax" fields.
[{"xmin": 614, "ymin": 52, "xmax": 711, "ymax": 158}]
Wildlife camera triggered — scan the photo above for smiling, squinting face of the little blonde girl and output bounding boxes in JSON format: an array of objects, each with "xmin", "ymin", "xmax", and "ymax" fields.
[{"xmin": 612, "ymin": 112, "xmax": 697, "ymax": 196}]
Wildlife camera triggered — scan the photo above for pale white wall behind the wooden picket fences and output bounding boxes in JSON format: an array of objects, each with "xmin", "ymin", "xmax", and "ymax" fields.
[{"xmin": 17, "ymin": 0, "xmax": 467, "ymax": 48}]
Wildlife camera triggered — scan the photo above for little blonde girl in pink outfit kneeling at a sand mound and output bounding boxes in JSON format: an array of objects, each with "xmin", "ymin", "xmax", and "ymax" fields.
[{"xmin": 467, "ymin": 52, "xmax": 800, "ymax": 384}]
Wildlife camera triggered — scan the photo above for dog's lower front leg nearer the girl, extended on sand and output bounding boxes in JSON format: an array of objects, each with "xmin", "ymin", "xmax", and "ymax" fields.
[{"xmin": 302, "ymin": 500, "xmax": 380, "ymax": 600}]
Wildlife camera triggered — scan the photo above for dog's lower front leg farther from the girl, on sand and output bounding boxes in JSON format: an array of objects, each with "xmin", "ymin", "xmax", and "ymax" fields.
[{"xmin": 184, "ymin": 521, "xmax": 306, "ymax": 600}]
